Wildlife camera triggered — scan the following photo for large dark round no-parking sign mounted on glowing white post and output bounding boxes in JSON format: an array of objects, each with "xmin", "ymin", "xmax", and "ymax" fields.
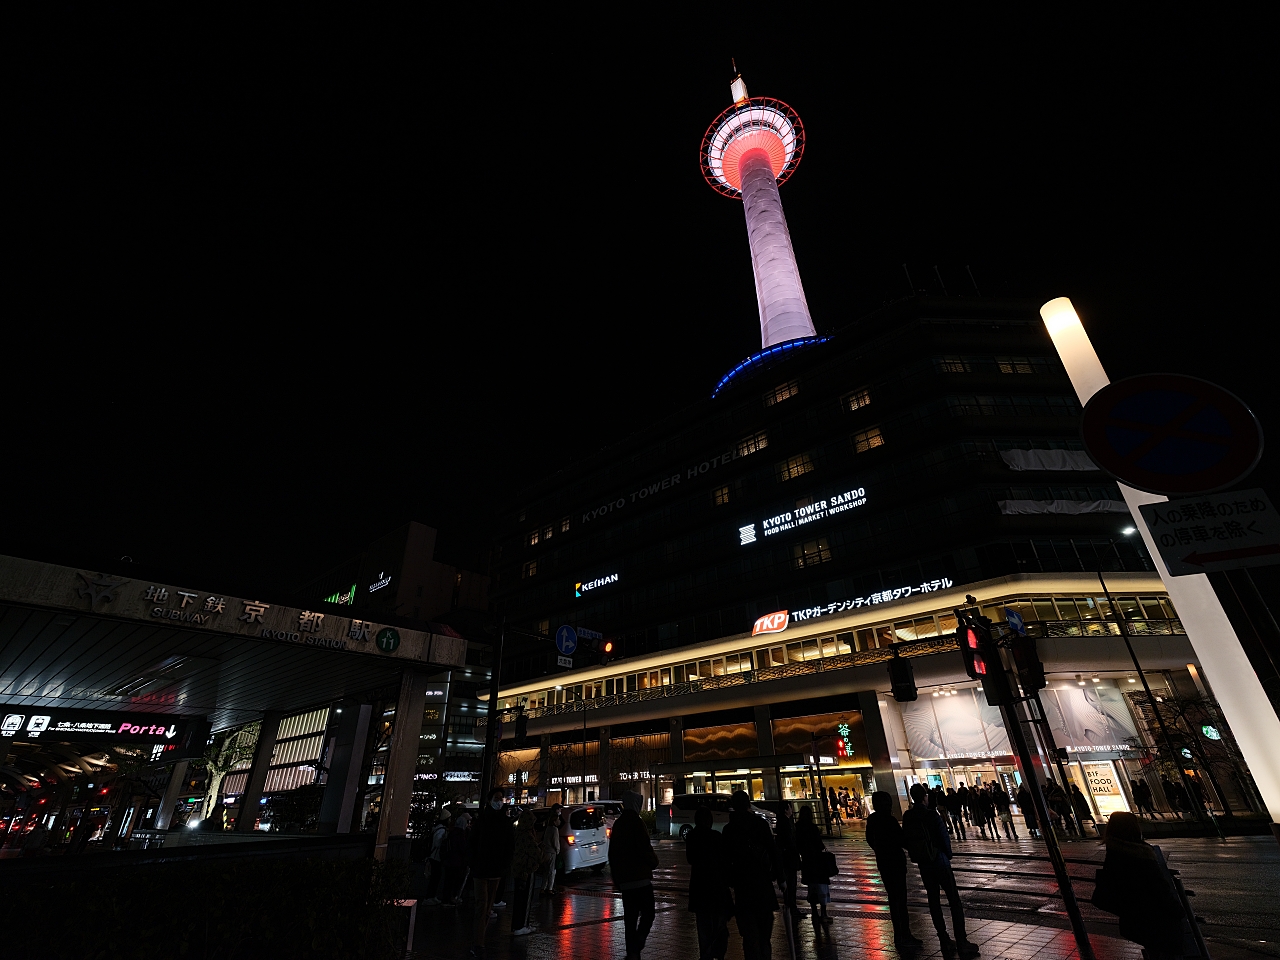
[{"xmin": 1080, "ymin": 374, "xmax": 1262, "ymax": 497}]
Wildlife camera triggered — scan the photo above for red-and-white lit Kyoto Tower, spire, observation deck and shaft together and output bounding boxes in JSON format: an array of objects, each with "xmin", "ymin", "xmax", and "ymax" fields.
[{"xmin": 701, "ymin": 74, "xmax": 815, "ymax": 349}]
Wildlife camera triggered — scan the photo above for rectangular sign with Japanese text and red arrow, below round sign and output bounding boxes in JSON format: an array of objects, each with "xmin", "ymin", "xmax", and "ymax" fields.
[{"xmin": 1138, "ymin": 490, "xmax": 1280, "ymax": 577}]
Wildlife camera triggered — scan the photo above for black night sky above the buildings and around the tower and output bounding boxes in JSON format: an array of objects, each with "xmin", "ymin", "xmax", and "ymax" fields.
[{"xmin": 0, "ymin": 13, "xmax": 1280, "ymax": 599}]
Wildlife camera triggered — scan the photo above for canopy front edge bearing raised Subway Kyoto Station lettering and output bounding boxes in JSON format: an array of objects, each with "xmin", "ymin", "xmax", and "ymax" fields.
[{"xmin": 0, "ymin": 557, "xmax": 466, "ymax": 667}]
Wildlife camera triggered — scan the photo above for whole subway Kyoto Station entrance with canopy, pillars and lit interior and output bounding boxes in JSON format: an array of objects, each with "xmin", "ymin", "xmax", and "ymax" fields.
[{"xmin": 0, "ymin": 557, "xmax": 466, "ymax": 856}]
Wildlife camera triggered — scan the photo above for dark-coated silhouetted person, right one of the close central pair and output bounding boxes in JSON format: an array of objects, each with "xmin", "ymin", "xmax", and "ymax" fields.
[{"xmin": 723, "ymin": 790, "xmax": 778, "ymax": 960}]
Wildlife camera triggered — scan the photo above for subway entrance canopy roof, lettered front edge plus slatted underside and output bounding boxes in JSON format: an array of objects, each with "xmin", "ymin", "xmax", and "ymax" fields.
[{"xmin": 0, "ymin": 557, "xmax": 466, "ymax": 731}]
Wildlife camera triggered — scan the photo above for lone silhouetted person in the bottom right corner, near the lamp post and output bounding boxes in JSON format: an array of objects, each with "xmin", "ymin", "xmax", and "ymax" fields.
[{"xmin": 1102, "ymin": 812, "xmax": 1190, "ymax": 960}]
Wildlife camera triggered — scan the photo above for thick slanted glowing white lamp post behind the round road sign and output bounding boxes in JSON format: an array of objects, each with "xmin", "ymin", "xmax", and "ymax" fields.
[{"xmin": 1041, "ymin": 297, "xmax": 1280, "ymax": 840}]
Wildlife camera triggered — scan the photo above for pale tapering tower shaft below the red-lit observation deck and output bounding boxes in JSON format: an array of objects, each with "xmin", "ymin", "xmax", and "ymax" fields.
[{"xmin": 739, "ymin": 150, "xmax": 815, "ymax": 349}]
